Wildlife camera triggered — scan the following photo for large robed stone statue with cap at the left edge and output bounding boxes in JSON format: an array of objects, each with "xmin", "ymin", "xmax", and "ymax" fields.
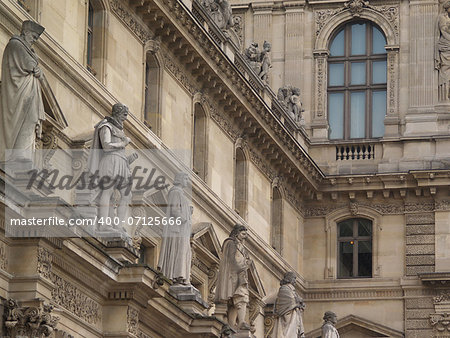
[{"xmin": 0, "ymin": 20, "xmax": 45, "ymax": 161}]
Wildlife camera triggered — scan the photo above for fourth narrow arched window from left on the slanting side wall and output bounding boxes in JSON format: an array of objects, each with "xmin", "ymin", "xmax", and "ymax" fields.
[{"xmin": 234, "ymin": 148, "xmax": 247, "ymax": 219}]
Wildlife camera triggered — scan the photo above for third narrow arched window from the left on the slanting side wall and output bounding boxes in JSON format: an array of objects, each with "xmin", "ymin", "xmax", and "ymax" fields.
[{"xmin": 192, "ymin": 103, "xmax": 207, "ymax": 180}]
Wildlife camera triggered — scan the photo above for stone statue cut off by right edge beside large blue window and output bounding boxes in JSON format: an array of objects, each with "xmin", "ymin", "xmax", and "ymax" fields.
[{"xmin": 434, "ymin": 1, "xmax": 450, "ymax": 99}]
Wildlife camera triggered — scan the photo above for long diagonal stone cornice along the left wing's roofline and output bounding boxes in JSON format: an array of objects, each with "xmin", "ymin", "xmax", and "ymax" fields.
[{"xmin": 118, "ymin": 0, "xmax": 323, "ymax": 195}]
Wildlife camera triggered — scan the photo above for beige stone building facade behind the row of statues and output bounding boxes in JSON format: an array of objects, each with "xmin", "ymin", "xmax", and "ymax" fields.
[{"xmin": 0, "ymin": 0, "xmax": 450, "ymax": 338}]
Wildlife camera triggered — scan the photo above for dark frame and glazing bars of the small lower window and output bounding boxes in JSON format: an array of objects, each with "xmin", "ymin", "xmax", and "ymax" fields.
[{"xmin": 336, "ymin": 217, "xmax": 374, "ymax": 279}]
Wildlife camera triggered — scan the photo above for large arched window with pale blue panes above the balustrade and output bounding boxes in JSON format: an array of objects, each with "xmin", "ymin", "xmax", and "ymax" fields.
[{"xmin": 328, "ymin": 21, "xmax": 387, "ymax": 140}]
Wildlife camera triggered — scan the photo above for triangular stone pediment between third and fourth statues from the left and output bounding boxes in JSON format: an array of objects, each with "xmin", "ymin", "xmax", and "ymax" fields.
[{"xmin": 191, "ymin": 222, "xmax": 221, "ymax": 263}]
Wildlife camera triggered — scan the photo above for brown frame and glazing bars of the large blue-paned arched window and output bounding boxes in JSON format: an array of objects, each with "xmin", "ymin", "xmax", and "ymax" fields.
[{"xmin": 327, "ymin": 20, "xmax": 388, "ymax": 141}]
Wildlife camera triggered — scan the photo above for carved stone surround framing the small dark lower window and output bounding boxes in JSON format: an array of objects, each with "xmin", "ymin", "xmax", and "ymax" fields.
[{"xmin": 325, "ymin": 203, "xmax": 382, "ymax": 279}]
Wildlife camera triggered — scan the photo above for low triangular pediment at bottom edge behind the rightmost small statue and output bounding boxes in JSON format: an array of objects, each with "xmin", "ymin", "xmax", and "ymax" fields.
[{"xmin": 306, "ymin": 315, "xmax": 404, "ymax": 338}]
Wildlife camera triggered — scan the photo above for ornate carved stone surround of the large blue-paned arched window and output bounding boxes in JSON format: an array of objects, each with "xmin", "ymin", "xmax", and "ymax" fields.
[{"xmin": 311, "ymin": 6, "xmax": 400, "ymax": 141}]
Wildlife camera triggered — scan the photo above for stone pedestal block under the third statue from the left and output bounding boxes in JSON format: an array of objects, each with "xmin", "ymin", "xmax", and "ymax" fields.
[{"xmin": 169, "ymin": 284, "xmax": 209, "ymax": 315}]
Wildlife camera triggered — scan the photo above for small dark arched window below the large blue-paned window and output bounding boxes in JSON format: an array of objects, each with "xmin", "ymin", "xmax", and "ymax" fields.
[{"xmin": 337, "ymin": 218, "xmax": 372, "ymax": 278}]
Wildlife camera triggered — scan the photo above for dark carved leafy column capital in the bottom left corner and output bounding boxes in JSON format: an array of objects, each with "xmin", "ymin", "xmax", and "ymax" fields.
[{"xmin": 5, "ymin": 299, "xmax": 59, "ymax": 338}]
